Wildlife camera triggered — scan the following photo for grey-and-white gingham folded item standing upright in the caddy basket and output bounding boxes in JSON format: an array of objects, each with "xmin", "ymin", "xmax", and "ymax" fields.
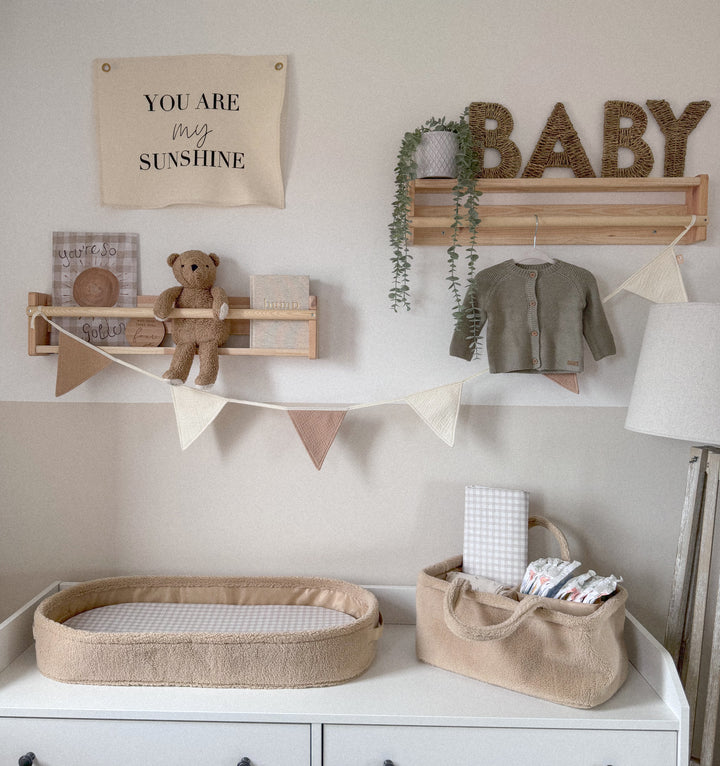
[{"xmin": 463, "ymin": 485, "xmax": 530, "ymax": 585}]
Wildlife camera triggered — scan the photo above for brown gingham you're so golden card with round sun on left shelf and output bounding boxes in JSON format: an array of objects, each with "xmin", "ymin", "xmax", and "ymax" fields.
[{"xmin": 50, "ymin": 231, "xmax": 139, "ymax": 346}]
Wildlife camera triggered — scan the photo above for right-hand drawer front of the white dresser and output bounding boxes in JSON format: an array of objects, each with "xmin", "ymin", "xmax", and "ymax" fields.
[{"xmin": 323, "ymin": 726, "xmax": 677, "ymax": 766}]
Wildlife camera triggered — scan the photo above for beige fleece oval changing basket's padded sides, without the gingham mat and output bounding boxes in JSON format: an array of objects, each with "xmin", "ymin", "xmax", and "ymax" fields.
[{"xmin": 33, "ymin": 577, "xmax": 382, "ymax": 688}]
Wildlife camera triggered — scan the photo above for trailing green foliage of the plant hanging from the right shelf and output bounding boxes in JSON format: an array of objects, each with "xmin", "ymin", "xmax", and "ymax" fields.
[{"xmin": 389, "ymin": 109, "xmax": 481, "ymax": 328}]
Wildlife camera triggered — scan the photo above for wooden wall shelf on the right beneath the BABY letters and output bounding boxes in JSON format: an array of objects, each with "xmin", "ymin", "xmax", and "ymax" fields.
[{"xmin": 410, "ymin": 175, "xmax": 708, "ymax": 246}]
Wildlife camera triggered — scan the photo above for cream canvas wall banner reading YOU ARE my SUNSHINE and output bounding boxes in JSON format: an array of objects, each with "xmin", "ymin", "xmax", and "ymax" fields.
[{"xmin": 93, "ymin": 54, "xmax": 287, "ymax": 208}]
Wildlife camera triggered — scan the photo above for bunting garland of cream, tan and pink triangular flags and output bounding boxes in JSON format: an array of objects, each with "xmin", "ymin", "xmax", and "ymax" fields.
[{"xmin": 31, "ymin": 222, "xmax": 695, "ymax": 470}]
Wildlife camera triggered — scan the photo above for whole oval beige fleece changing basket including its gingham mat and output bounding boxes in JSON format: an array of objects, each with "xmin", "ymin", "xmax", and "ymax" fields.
[{"xmin": 33, "ymin": 577, "xmax": 382, "ymax": 688}]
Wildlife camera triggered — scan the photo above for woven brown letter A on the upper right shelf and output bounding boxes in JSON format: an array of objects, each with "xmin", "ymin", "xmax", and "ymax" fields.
[{"xmin": 522, "ymin": 102, "xmax": 595, "ymax": 178}]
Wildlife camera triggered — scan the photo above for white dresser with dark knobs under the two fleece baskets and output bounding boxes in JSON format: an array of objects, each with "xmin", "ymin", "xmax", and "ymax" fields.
[{"xmin": 0, "ymin": 583, "xmax": 688, "ymax": 766}]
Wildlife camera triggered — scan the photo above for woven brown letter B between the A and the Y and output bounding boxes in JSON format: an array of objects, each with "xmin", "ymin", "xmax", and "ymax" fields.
[{"xmin": 602, "ymin": 101, "xmax": 655, "ymax": 178}]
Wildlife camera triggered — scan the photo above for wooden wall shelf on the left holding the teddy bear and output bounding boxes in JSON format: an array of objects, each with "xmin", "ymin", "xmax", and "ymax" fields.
[{"xmin": 26, "ymin": 293, "xmax": 318, "ymax": 359}]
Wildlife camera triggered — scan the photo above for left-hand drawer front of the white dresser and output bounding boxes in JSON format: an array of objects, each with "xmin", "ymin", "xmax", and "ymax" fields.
[{"xmin": 0, "ymin": 718, "xmax": 310, "ymax": 766}]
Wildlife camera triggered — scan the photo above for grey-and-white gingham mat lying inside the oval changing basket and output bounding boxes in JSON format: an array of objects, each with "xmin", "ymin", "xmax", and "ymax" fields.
[{"xmin": 64, "ymin": 602, "xmax": 355, "ymax": 633}]
